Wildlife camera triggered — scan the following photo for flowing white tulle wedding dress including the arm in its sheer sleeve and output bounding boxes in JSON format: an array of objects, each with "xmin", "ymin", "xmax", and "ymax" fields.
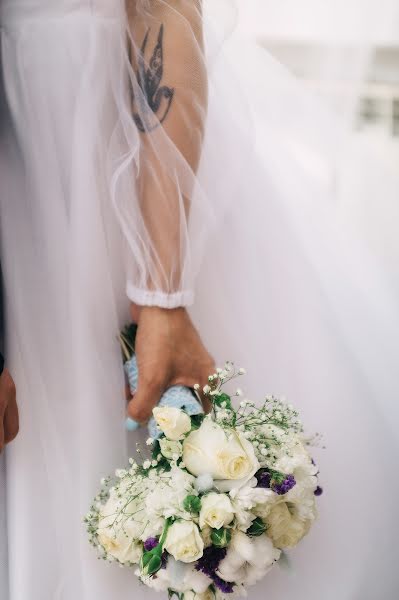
[{"xmin": 0, "ymin": 0, "xmax": 399, "ymax": 600}]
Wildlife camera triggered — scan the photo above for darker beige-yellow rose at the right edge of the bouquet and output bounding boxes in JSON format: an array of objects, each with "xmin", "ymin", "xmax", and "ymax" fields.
[{"xmin": 266, "ymin": 502, "xmax": 313, "ymax": 548}]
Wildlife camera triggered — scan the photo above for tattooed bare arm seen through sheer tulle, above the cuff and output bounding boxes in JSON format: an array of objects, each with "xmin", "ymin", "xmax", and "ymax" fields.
[{"xmin": 129, "ymin": 0, "xmax": 208, "ymax": 286}]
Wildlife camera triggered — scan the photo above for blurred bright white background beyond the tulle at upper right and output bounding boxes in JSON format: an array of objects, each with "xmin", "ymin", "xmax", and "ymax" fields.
[{"xmin": 237, "ymin": 0, "xmax": 399, "ymax": 284}]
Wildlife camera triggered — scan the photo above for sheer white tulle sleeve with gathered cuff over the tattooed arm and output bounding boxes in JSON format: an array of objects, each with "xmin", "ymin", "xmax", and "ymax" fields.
[{"xmin": 112, "ymin": 0, "xmax": 207, "ymax": 308}]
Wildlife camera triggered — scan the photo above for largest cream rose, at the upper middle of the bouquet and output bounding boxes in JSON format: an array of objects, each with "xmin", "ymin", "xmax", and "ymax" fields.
[{"xmin": 183, "ymin": 418, "xmax": 259, "ymax": 492}]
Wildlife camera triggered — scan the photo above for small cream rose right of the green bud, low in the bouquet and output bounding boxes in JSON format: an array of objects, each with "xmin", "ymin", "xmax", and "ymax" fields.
[{"xmin": 164, "ymin": 521, "xmax": 204, "ymax": 563}]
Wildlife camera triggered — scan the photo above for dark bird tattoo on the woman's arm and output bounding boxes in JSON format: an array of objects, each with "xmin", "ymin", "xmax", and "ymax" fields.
[{"xmin": 129, "ymin": 25, "xmax": 175, "ymax": 133}]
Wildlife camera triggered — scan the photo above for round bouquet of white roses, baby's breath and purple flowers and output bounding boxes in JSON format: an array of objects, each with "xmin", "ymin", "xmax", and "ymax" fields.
[{"xmin": 85, "ymin": 363, "xmax": 321, "ymax": 600}]
